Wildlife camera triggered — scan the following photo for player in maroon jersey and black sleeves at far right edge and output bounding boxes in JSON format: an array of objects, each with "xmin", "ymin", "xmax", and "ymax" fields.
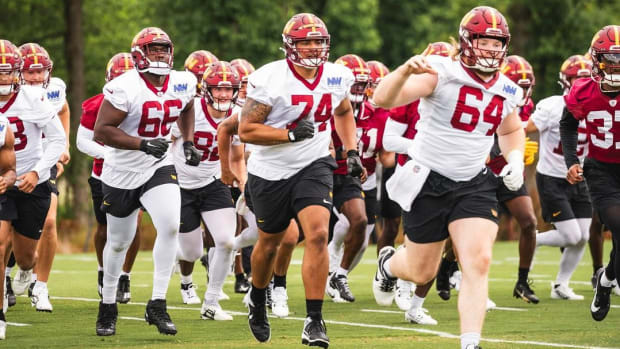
[{"xmin": 560, "ymin": 25, "xmax": 620, "ymax": 321}]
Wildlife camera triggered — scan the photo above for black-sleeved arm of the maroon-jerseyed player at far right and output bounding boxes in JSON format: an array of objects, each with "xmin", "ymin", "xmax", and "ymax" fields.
[{"xmin": 560, "ymin": 108, "xmax": 583, "ymax": 184}]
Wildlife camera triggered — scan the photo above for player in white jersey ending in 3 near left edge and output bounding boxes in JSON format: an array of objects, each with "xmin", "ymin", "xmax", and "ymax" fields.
[{"xmin": 0, "ymin": 40, "xmax": 66, "ymax": 318}]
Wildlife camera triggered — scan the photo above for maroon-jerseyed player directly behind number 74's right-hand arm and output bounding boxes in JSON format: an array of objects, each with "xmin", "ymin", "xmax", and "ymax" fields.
[{"xmin": 326, "ymin": 54, "xmax": 394, "ymax": 302}]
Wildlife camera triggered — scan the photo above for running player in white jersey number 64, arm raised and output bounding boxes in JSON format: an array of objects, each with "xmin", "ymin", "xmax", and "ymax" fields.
[{"xmin": 373, "ymin": 6, "xmax": 525, "ymax": 349}]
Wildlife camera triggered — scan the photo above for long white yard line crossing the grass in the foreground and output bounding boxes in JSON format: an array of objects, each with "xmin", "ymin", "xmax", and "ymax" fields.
[{"xmin": 50, "ymin": 297, "xmax": 620, "ymax": 349}]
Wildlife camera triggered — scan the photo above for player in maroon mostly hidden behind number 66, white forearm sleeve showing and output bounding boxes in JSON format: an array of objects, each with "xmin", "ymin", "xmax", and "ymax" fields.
[{"xmin": 76, "ymin": 52, "xmax": 142, "ymax": 303}]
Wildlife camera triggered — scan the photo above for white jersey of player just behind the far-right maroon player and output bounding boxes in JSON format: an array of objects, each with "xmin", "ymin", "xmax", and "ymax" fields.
[{"xmin": 530, "ymin": 96, "xmax": 588, "ymax": 178}]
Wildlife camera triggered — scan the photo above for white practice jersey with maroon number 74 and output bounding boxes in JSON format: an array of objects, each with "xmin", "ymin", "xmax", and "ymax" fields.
[{"xmin": 246, "ymin": 60, "xmax": 354, "ymax": 181}]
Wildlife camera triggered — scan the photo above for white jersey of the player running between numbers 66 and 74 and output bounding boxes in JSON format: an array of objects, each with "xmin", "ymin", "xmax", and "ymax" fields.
[{"xmin": 171, "ymin": 97, "xmax": 236, "ymax": 189}]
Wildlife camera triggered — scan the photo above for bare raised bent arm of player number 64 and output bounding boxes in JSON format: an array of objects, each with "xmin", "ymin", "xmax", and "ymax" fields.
[{"xmin": 372, "ymin": 55, "xmax": 438, "ymax": 109}]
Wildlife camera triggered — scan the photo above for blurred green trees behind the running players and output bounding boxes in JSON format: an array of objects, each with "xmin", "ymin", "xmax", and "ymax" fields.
[{"xmin": 0, "ymin": 0, "xmax": 620, "ymax": 250}]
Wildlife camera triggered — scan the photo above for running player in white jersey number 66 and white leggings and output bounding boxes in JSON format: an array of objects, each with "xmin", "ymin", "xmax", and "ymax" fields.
[{"xmin": 95, "ymin": 27, "xmax": 200, "ymax": 336}]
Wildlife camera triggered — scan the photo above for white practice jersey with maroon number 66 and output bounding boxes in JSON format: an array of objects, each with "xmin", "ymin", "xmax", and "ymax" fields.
[{"xmin": 101, "ymin": 70, "xmax": 196, "ymax": 189}]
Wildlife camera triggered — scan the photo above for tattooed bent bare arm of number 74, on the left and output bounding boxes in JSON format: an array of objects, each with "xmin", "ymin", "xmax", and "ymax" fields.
[{"xmin": 239, "ymin": 97, "xmax": 294, "ymax": 145}]
